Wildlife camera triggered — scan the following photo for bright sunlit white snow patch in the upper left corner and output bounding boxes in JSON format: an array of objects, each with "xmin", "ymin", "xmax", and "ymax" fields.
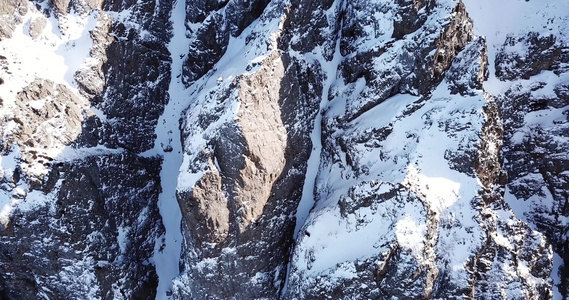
[{"xmin": 0, "ymin": 3, "xmax": 98, "ymax": 106}]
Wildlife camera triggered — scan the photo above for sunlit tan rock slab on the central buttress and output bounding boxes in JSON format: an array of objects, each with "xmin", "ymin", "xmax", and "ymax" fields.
[{"xmin": 180, "ymin": 53, "xmax": 287, "ymax": 250}]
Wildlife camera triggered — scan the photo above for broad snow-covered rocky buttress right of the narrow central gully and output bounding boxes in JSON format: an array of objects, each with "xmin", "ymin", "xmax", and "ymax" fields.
[{"xmin": 285, "ymin": 3, "xmax": 551, "ymax": 299}]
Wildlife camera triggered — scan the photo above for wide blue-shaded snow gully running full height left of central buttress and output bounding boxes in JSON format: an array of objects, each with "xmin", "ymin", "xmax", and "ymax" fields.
[{"xmin": 145, "ymin": 1, "xmax": 189, "ymax": 300}]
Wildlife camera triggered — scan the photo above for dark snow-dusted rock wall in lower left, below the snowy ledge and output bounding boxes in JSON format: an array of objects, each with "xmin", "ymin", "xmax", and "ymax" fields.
[{"xmin": 0, "ymin": 154, "xmax": 163, "ymax": 299}]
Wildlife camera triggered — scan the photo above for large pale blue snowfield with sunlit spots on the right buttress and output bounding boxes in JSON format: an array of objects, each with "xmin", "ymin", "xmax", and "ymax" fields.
[{"xmin": 292, "ymin": 40, "xmax": 486, "ymax": 284}]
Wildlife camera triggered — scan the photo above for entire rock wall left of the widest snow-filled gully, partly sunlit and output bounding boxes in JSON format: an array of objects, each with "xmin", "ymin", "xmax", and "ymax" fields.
[{"xmin": 0, "ymin": 1, "xmax": 170, "ymax": 299}]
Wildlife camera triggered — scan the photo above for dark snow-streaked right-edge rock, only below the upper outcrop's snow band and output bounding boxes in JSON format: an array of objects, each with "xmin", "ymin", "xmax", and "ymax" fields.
[{"xmin": 496, "ymin": 72, "xmax": 569, "ymax": 295}]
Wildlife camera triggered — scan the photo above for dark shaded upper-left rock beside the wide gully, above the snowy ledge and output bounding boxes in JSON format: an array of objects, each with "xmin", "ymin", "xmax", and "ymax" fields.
[{"xmin": 77, "ymin": 1, "xmax": 172, "ymax": 153}]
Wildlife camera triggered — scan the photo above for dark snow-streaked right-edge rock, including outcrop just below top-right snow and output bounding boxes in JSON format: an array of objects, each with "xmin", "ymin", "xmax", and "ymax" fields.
[{"xmin": 496, "ymin": 33, "xmax": 569, "ymax": 295}]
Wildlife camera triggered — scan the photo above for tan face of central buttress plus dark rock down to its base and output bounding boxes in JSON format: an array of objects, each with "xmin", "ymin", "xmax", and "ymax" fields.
[{"xmin": 178, "ymin": 47, "xmax": 318, "ymax": 299}]
